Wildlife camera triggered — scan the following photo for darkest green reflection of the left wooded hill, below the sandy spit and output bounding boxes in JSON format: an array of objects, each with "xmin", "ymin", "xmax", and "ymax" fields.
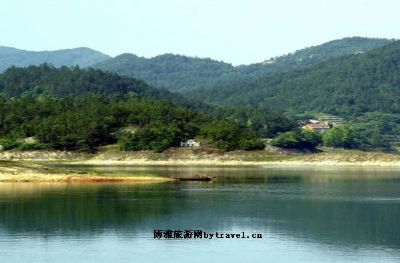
[{"xmin": 0, "ymin": 184, "xmax": 186, "ymax": 235}]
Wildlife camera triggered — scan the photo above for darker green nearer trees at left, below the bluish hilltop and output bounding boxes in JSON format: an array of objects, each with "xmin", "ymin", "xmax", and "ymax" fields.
[{"xmin": 0, "ymin": 95, "xmax": 205, "ymax": 151}]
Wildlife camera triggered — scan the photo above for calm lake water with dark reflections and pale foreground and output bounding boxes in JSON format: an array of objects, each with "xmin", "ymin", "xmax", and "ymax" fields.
[{"xmin": 0, "ymin": 166, "xmax": 400, "ymax": 263}]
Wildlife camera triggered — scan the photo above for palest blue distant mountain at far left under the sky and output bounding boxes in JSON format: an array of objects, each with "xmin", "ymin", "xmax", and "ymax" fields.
[{"xmin": 0, "ymin": 47, "xmax": 110, "ymax": 71}]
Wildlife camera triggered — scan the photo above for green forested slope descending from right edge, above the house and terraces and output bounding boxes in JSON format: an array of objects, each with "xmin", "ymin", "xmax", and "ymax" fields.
[{"xmin": 188, "ymin": 41, "xmax": 400, "ymax": 116}]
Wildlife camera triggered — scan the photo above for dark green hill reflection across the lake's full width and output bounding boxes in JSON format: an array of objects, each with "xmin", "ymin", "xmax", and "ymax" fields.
[{"xmin": 0, "ymin": 168, "xmax": 400, "ymax": 262}]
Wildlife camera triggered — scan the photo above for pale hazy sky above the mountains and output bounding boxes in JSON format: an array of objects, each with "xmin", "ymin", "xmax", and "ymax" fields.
[{"xmin": 0, "ymin": 0, "xmax": 400, "ymax": 65}]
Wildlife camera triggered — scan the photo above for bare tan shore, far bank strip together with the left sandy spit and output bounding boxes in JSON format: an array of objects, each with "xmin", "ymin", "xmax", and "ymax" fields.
[{"xmin": 0, "ymin": 152, "xmax": 400, "ymax": 184}]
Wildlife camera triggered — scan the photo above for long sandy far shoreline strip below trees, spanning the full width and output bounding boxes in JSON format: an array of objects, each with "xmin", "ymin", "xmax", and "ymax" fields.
[{"xmin": 0, "ymin": 145, "xmax": 400, "ymax": 171}]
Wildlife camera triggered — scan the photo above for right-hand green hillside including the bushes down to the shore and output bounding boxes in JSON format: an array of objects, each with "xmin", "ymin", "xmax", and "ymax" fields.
[{"xmin": 184, "ymin": 41, "xmax": 400, "ymax": 149}]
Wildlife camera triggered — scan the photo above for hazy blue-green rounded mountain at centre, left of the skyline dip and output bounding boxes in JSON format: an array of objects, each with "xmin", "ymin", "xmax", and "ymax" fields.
[{"xmin": 92, "ymin": 54, "xmax": 236, "ymax": 91}]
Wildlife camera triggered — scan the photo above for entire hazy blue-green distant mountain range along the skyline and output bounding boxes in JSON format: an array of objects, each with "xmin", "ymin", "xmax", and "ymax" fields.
[{"xmin": 0, "ymin": 37, "xmax": 391, "ymax": 93}]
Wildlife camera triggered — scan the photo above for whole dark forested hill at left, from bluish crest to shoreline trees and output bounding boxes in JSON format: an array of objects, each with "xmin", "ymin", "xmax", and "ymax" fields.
[{"xmin": 0, "ymin": 64, "xmax": 293, "ymax": 151}]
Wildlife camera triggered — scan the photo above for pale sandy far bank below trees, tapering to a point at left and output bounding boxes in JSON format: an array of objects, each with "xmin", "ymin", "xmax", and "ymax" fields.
[{"xmin": 74, "ymin": 149, "xmax": 400, "ymax": 167}]
